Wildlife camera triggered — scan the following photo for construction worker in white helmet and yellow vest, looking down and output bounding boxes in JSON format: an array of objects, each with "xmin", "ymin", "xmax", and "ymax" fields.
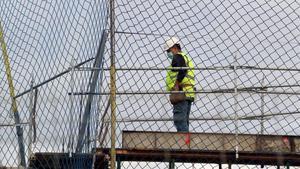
[{"xmin": 164, "ymin": 37, "xmax": 195, "ymax": 132}]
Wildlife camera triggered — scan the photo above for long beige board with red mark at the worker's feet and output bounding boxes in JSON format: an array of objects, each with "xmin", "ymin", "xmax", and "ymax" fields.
[{"xmin": 122, "ymin": 131, "xmax": 300, "ymax": 153}]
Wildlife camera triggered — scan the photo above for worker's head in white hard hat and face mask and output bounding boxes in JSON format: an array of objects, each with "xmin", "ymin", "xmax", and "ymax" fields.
[{"xmin": 164, "ymin": 37, "xmax": 181, "ymax": 59}]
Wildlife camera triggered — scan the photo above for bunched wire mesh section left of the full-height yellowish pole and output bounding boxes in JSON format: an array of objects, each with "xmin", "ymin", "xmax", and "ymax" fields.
[{"xmin": 0, "ymin": 0, "xmax": 107, "ymax": 168}]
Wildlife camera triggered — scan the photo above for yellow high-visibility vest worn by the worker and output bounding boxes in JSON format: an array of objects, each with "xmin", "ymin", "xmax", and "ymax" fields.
[{"xmin": 166, "ymin": 52, "xmax": 195, "ymax": 99}]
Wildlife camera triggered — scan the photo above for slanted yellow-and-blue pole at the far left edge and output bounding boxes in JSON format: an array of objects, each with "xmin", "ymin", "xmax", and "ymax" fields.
[{"xmin": 0, "ymin": 22, "xmax": 26, "ymax": 167}]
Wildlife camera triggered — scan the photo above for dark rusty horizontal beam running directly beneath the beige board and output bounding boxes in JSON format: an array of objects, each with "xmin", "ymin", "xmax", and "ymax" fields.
[{"xmin": 97, "ymin": 149, "xmax": 300, "ymax": 166}]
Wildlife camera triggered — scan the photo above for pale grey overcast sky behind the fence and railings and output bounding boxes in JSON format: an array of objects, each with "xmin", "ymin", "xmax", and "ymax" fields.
[{"xmin": 0, "ymin": 0, "xmax": 300, "ymax": 168}]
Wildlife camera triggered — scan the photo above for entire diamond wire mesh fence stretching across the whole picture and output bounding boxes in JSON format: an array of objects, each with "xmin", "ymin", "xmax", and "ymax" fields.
[{"xmin": 0, "ymin": 0, "xmax": 300, "ymax": 168}]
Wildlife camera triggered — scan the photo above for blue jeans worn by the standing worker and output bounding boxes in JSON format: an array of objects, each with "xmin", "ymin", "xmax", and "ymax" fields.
[{"xmin": 173, "ymin": 100, "xmax": 192, "ymax": 132}]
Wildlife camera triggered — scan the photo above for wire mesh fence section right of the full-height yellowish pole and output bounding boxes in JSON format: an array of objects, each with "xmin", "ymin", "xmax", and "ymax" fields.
[{"xmin": 98, "ymin": 0, "xmax": 300, "ymax": 168}]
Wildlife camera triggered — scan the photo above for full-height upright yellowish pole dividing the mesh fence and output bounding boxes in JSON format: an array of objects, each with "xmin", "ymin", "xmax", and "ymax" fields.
[{"xmin": 110, "ymin": 0, "xmax": 116, "ymax": 169}]
